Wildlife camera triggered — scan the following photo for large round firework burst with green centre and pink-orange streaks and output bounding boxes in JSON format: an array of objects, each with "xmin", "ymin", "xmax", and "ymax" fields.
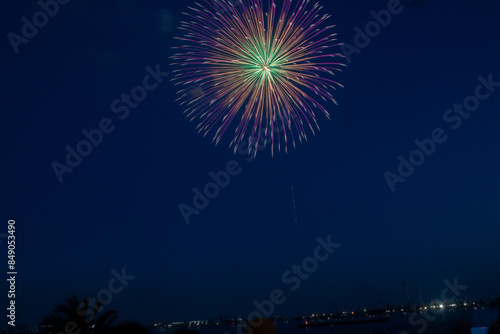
[{"xmin": 171, "ymin": 0, "xmax": 345, "ymax": 155}]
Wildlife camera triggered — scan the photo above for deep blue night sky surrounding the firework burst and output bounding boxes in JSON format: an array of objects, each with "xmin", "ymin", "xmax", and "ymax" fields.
[{"xmin": 0, "ymin": 0, "xmax": 500, "ymax": 323}]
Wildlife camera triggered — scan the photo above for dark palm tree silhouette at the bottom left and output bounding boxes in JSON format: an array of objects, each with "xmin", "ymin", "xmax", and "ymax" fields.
[{"xmin": 40, "ymin": 293, "xmax": 118, "ymax": 334}]
